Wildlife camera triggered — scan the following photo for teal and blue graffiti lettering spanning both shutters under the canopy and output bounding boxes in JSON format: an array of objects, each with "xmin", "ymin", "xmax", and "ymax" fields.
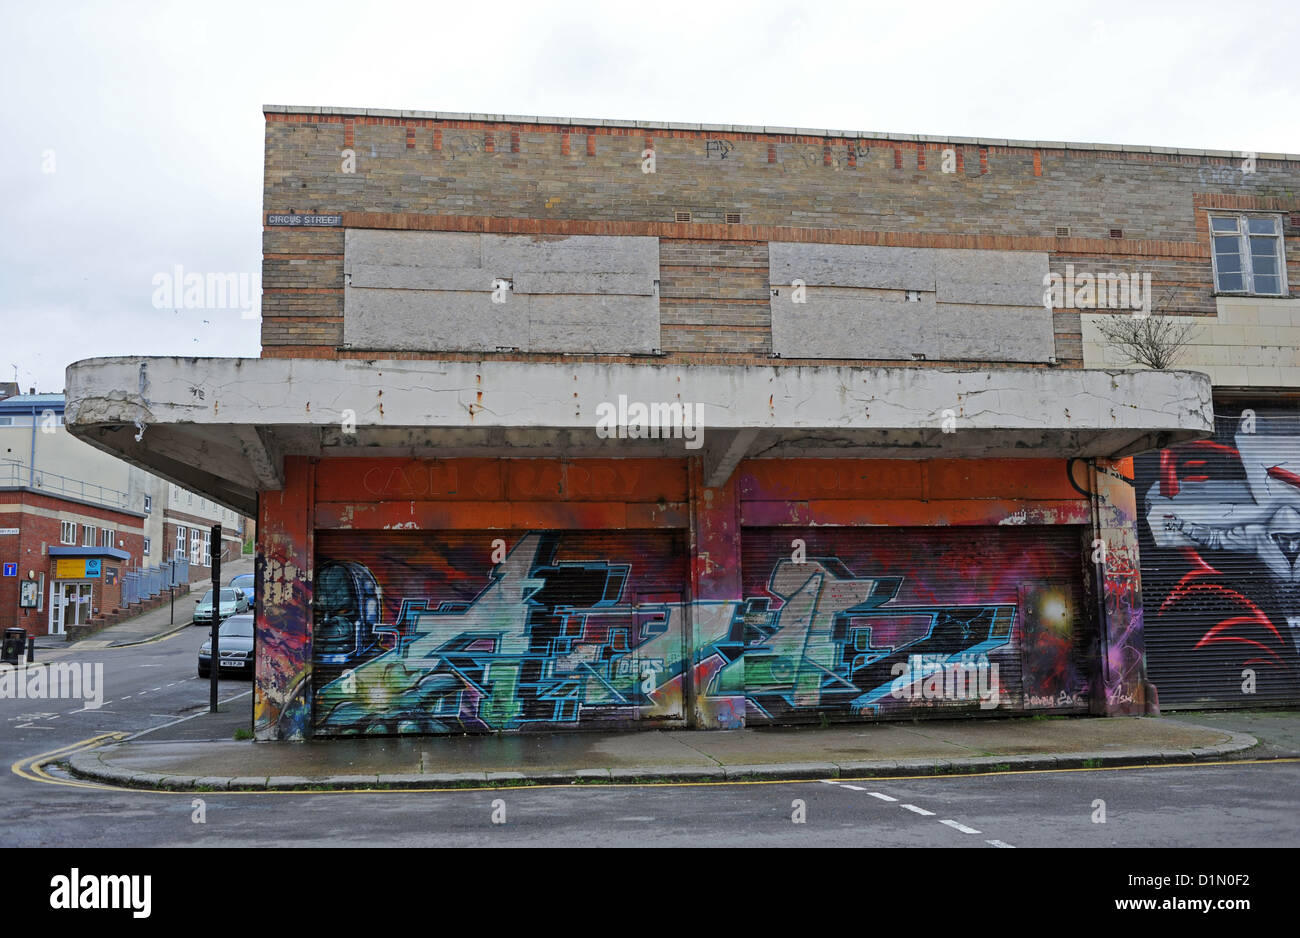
[{"xmin": 313, "ymin": 531, "xmax": 1087, "ymax": 735}]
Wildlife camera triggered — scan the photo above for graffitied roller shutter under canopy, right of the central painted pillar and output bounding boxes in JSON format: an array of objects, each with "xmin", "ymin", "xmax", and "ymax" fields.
[{"xmin": 742, "ymin": 525, "xmax": 1096, "ymax": 724}]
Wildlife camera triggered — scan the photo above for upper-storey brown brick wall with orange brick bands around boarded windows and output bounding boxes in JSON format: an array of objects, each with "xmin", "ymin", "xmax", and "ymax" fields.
[{"xmin": 263, "ymin": 113, "xmax": 1300, "ymax": 366}]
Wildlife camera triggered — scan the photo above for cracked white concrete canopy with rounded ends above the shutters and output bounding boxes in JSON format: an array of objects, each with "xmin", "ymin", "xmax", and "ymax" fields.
[{"xmin": 65, "ymin": 357, "xmax": 1213, "ymax": 514}]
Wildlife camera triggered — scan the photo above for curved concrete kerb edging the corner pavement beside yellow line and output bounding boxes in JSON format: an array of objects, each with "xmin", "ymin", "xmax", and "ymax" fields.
[{"xmin": 55, "ymin": 733, "xmax": 1274, "ymax": 791}]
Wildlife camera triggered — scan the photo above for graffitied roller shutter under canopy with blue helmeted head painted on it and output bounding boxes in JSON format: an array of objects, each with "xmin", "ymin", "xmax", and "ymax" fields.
[{"xmin": 312, "ymin": 531, "xmax": 686, "ymax": 735}]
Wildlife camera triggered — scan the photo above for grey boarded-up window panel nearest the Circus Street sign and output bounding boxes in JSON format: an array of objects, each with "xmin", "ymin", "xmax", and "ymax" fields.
[{"xmin": 343, "ymin": 229, "xmax": 659, "ymax": 352}]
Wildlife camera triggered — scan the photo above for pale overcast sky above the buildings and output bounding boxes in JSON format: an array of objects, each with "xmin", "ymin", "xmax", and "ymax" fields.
[{"xmin": 0, "ymin": 0, "xmax": 1300, "ymax": 391}]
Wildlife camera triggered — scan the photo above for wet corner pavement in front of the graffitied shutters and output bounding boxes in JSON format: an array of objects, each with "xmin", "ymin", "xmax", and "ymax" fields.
[{"xmin": 61, "ymin": 701, "xmax": 1300, "ymax": 791}]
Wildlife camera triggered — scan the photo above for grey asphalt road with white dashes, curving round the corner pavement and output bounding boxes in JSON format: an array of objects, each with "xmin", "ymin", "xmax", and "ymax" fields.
[{"xmin": 0, "ymin": 627, "xmax": 1300, "ymax": 850}]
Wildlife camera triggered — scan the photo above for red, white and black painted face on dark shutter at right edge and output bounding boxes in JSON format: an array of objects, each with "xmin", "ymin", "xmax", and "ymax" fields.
[{"xmin": 1136, "ymin": 407, "xmax": 1300, "ymax": 705}]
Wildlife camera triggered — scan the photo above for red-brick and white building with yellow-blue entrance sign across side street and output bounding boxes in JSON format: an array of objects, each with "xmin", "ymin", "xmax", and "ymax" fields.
[{"xmin": 0, "ymin": 385, "xmax": 251, "ymax": 635}]
